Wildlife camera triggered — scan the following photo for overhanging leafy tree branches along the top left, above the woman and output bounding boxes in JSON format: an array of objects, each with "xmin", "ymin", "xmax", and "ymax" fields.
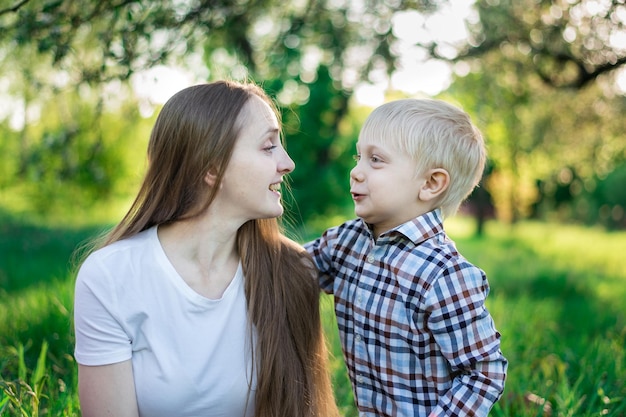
[{"xmin": 0, "ymin": 0, "xmax": 439, "ymax": 84}]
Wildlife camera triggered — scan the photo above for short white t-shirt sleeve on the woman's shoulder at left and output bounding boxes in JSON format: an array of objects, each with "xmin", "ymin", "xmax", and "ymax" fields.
[{"xmin": 74, "ymin": 252, "xmax": 132, "ymax": 366}]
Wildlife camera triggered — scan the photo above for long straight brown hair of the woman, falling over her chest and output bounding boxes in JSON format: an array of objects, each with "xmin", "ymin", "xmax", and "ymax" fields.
[{"xmin": 94, "ymin": 81, "xmax": 338, "ymax": 417}]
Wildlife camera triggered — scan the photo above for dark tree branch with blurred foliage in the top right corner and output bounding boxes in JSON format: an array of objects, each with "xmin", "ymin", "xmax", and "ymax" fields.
[{"xmin": 448, "ymin": 0, "xmax": 626, "ymax": 89}]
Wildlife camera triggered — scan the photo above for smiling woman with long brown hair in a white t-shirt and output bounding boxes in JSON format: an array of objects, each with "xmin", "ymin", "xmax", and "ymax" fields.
[{"xmin": 75, "ymin": 82, "xmax": 338, "ymax": 417}]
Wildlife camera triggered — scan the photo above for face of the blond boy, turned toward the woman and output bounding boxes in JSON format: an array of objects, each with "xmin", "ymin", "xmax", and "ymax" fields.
[{"xmin": 350, "ymin": 138, "xmax": 432, "ymax": 237}]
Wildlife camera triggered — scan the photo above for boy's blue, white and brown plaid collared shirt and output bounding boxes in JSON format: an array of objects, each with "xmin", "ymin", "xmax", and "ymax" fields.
[{"xmin": 306, "ymin": 210, "xmax": 507, "ymax": 417}]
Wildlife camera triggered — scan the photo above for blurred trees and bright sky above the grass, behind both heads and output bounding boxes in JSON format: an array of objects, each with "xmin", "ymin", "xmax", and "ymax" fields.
[{"xmin": 0, "ymin": 0, "xmax": 626, "ymax": 229}]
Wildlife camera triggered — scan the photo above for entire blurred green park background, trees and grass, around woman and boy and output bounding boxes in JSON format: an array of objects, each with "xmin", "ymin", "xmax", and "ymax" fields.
[{"xmin": 0, "ymin": 0, "xmax": 626, "ymax": 416}]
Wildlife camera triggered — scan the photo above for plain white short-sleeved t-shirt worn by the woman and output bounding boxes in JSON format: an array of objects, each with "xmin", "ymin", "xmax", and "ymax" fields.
[{"xmin": 74, "ymin": 227, "xmax": 256, "ymax": 417}]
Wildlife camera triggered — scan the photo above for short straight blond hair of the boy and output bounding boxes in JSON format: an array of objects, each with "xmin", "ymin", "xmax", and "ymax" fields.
[{"xmin": 359, "ymin": 99, "xmax": 487, "ymax": 217}]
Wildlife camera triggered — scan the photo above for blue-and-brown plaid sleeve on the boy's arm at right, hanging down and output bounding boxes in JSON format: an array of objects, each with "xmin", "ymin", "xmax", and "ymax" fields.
[{"xmin": 427, "ymin": 263, "xmax": 507, "ymax": 417}]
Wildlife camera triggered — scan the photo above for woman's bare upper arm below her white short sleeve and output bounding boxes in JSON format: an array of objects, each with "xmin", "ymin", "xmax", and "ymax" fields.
[{"xmin": 78, "ymin": 360, "xmax": 139, "ymax": 417}]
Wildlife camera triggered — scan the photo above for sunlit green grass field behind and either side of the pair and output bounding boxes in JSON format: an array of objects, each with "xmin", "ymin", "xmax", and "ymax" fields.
[{"xmin": 0, "ymin": 215, "xmax": 626, "ymax": 417}]
